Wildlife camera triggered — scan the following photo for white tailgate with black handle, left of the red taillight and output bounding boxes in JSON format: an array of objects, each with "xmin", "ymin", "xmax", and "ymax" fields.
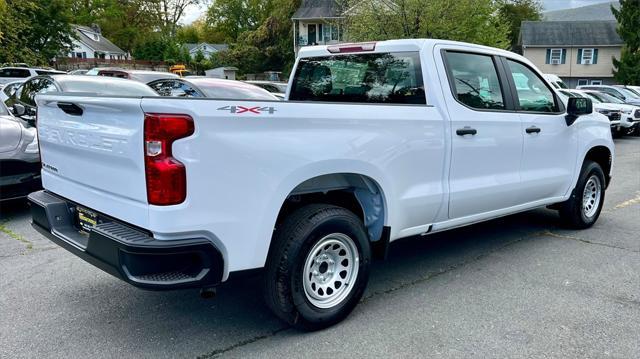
[{"xmin": 37, "ymin": 95, "xmax": 148, "ymax": 226}]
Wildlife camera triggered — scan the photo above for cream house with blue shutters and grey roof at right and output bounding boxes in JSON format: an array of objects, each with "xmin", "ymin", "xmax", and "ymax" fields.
[{"xmin": 520, "ymin": 20, "xmax": 623, "ymax": 88}]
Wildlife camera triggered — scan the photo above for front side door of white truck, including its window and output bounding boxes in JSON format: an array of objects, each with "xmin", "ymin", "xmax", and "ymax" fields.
[{"xmin": 504, "ymin": 59, "xmax": 578, "ymax": 203}]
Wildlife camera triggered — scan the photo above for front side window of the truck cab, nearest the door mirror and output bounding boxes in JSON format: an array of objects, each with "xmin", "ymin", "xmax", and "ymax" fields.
[{"xmin": 507, "ymin": 59, "xmax": 557, "ymax": 112}]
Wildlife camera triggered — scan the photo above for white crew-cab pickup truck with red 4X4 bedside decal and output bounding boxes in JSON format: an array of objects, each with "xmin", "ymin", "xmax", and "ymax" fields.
[{"xmin": 29, "ymin": 40, "xmax": 614, "ymax": 330}]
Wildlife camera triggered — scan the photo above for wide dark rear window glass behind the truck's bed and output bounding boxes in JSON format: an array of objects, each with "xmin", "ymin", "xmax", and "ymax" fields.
[{"xmin": 289, "ymin": 52, "xmax": 426, "ymax": 104}]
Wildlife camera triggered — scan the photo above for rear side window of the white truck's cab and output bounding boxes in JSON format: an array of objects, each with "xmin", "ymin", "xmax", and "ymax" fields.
[{"xmin": 446, "ymin": 51, "xmax": 505, "ymax": 110}]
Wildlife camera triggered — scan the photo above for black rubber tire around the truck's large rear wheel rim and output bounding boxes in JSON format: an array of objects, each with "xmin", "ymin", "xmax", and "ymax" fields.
[{"xmin": 263, "ymin": 204, "xmax": 371, "ymax": 331}]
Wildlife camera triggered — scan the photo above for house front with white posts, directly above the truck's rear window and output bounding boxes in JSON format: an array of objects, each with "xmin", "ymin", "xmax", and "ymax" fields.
[{"xmin": 291, "ymin": 0, "xmax": 344, "ymax": 54}]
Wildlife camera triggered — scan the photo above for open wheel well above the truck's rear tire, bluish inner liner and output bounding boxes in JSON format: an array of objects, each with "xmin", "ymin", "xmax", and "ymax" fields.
[{"xmin": 276, "ymin": 173, "xmax": 386, "ymax": 241}]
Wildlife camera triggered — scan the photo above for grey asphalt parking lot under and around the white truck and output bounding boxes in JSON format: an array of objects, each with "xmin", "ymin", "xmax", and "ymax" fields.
[{"xmin": 0, "ymin": 137, "xmax": 640, "ymax": 358}]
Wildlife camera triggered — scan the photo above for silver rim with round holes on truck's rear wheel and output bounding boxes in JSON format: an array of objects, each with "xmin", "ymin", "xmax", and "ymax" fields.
[{"xmin": 302, "ymin": 233, "xmax": 360, "ymax": 309}]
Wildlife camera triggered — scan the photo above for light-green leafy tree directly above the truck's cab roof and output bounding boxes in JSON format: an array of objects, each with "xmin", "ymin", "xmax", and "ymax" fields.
[{"xmin": 342, "ymin": 0, "xmax": 509, "ymax": 48}]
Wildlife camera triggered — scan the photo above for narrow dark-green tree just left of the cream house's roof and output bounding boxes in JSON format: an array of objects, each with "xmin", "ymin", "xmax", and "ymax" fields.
[{"xmin": 498, "ymin": 0, "xmax": 542, "ymax": 51}]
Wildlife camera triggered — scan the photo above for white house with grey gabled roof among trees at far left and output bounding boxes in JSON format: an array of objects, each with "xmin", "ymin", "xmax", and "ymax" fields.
[{"xmin": 69, "ymin": 24, "xmax": 129, "ymax": 60}]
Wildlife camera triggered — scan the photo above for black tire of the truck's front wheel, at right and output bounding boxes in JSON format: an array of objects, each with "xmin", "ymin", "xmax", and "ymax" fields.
[{"xmin": 560, "ymin": 160, "xmax": 606, "ymax": 229}]
